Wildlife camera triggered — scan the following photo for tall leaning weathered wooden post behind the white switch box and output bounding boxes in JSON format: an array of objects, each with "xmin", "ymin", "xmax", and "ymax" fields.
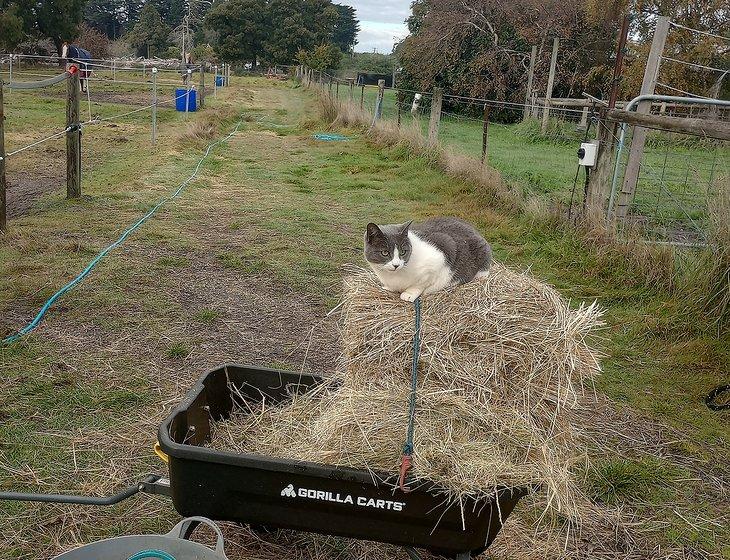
[{"xmin": 616, "ymin": 16, "xmax": 669, "ymax": 220}]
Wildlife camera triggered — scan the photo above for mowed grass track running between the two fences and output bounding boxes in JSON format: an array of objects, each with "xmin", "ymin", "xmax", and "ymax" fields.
[{"xmin": 0, "ymin": 79, "xmax": 730, "ymax": 559}]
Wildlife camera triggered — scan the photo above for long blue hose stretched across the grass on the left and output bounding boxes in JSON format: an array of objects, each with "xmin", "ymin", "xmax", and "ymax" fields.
[{"xmin": 0, "ymin": 119, "xmax": 243, "ymax": 346}]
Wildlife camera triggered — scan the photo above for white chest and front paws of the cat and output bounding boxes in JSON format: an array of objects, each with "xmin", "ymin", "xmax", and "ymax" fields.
[{"xmin": 372, "ymin": 232, "xmax": 453, "ymax": 301}]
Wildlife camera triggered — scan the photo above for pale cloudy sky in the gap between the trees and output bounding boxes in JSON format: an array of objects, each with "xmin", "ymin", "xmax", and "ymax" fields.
[{"xmin": 335, "ymin": 0, "xmax": 411, "ymax": 54}]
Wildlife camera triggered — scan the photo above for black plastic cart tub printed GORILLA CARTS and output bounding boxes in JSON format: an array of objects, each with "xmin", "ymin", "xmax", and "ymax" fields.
[{"xmin": 159, "ymin": 365, "xmax": 524, "ymax": 557}]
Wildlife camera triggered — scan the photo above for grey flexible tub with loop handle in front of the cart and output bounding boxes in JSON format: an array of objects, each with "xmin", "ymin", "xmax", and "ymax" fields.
[{"xmin": 54, "ymin": 517, "xmax": 227, "ymax": 560}]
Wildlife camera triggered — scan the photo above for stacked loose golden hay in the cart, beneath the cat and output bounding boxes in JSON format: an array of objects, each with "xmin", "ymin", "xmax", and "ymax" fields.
[{"xmin": 212, "ymin": 265, "xmax": 602, "ymax": 515}]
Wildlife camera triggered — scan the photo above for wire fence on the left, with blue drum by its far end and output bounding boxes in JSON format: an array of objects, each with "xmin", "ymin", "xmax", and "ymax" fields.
[{"xmin": 0, "ymin": 62, "xmax": 225, "ymax": 229}]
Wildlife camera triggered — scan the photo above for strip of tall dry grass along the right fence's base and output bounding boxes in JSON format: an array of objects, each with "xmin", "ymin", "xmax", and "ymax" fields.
[{"xmin": 312, "ymin": 88, "xmax": 730, "ymax": 333}]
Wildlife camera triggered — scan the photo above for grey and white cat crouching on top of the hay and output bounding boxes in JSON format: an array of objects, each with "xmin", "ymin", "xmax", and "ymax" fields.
[{"xmin": 365, "ymin": 218, "xmax": 492, "ymax": 301}]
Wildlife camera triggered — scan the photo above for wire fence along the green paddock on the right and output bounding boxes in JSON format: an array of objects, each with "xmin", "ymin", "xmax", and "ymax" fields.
[{"xmin": 320, "ymin": 69, "xmax": 730, "ymax": 244}]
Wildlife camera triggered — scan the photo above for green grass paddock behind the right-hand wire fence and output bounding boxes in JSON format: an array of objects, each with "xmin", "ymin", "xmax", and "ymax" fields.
[{"xmin": 339, "ymin": 85, "xmax": 730, "ymax": 237}]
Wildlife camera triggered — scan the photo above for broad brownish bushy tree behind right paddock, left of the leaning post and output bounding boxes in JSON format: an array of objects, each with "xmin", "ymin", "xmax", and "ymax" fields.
[{"xmin": 397, "ymin": 0, "xmax": 615, "ymax": 118}]
